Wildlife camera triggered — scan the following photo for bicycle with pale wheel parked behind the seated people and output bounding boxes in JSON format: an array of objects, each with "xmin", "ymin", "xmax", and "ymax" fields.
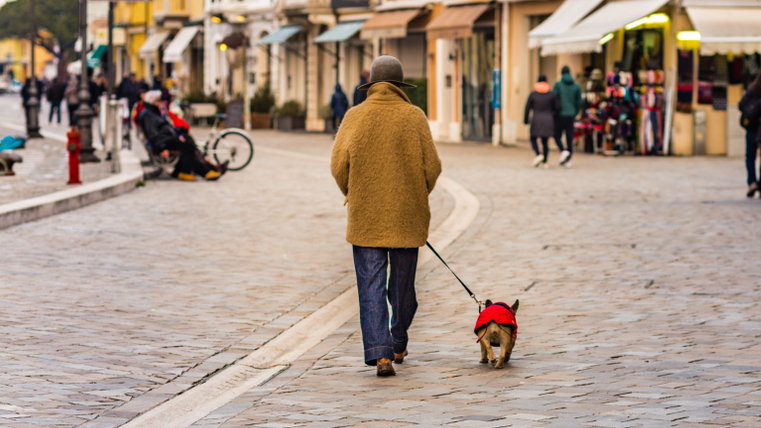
[{"xmin": 146, "ymin": 110, "xmax": 254, "ymax": 175}]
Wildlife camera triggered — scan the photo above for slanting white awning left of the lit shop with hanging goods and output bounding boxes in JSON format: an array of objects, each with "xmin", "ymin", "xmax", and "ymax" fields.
[{"xmin": 542, "ymin": 0, "xmax": 668, "ymax": 56}]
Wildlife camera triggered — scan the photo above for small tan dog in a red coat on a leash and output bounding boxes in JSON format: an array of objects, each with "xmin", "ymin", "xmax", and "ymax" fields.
[{"xmin": 473, "ymin": 300, "xmax": 520, "ymax": 369}]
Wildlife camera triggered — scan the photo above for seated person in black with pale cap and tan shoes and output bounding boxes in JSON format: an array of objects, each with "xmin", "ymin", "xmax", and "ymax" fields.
[{"xmin": 137, "ymin": 91, "xmax": 222, "ymax": 181}]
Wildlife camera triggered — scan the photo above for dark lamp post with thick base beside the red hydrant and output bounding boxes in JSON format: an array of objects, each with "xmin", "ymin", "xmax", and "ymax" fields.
[{"xmin": 76, "ymin": 0, "xmax": 100, "ymax": 163}]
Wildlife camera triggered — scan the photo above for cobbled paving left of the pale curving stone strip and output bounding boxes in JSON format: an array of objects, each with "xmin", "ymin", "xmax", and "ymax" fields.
[{"xmin": 0, "ymin": 133, "xmax": 452, "ymax": 427}]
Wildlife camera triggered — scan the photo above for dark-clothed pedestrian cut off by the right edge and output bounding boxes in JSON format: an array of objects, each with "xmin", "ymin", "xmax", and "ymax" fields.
[{"xmin": 739, "ymin": 71, "xmax": 761, "ymax": 198}]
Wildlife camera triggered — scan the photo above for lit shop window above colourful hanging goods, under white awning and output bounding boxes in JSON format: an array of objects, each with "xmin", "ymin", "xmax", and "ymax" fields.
[{"xmin": 622, "ymin": 28, "xmax": 663, "ymax": 86}]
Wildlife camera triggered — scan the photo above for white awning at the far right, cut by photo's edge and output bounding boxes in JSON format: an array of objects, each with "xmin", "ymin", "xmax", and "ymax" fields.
[{"xmin": 687, "ymin": 7, "xmax": 761, "ymax": 55}]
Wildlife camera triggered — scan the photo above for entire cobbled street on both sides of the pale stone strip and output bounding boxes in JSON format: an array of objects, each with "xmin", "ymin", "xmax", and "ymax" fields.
[{"xmin": 0, "ymin": 126, "xmax": 761, "ymax": 427}]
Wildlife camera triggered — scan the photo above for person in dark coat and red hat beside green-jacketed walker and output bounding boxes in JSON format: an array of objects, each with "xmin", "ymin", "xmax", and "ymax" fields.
[{"xmin": 523, "ymin": 75, "xmax": 559, "ymax": 168}]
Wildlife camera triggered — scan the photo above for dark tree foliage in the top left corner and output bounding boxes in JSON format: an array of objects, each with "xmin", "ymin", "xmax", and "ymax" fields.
[{"xmin": 0, "ymin": 0, "xmax": 79, "ymax": 76}]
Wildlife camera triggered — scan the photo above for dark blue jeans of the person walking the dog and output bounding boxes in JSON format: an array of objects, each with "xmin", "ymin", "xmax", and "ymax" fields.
[{"xmin": 354, "ymin": 245, "xmax": 418, "ymax": 366}]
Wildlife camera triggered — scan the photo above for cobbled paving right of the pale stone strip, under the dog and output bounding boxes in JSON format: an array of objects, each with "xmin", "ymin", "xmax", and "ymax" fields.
[{"xmin": 195, "ymin": 146, "xmax": 761, "ymax": 428}]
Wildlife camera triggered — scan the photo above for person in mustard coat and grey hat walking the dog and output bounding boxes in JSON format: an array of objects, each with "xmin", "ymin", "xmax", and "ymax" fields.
[{"xmin": 330, "ymin": 56, "xmax": 441, "ymax": 376}]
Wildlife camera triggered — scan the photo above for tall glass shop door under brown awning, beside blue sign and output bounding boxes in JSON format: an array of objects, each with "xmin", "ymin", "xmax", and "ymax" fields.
[{"xmin": 462, "ymin": 29, "xmax": 494, "ymax": 141}]
